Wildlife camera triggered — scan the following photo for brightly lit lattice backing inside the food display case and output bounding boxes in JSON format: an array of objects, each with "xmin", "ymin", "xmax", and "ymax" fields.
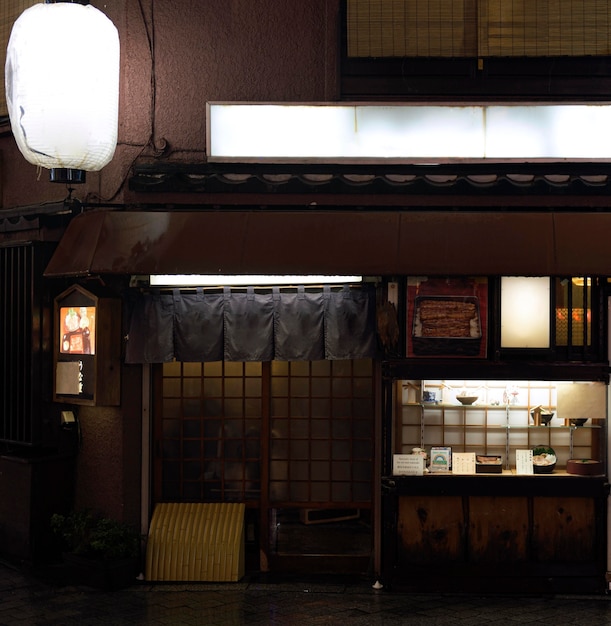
[{"xmin": 394, "ymin": 381, "xmax": 602, "ymax": 470}]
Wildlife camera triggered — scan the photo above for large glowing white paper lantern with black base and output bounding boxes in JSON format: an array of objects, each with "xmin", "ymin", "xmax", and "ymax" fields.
[{"xmin": 5, "ymin": 0, "xmax": 119, "ymax": 183}]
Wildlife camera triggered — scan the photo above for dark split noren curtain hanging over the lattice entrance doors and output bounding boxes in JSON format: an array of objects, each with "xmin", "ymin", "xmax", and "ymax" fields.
[{"xmin": 126, "ymin": 286, "xmax": 377, "ymax": 363}]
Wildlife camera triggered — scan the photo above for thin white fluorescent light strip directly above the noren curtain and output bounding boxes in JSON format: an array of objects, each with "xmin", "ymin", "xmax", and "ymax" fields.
[{"xmin": 149, "ymin": 274, "xmax": 363, "ymax": 287}]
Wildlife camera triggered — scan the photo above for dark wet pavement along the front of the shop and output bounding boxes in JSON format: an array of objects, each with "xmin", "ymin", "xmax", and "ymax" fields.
[{"xmin": 0, "ymin": 561, "xmax": 611, "ymax": 626}]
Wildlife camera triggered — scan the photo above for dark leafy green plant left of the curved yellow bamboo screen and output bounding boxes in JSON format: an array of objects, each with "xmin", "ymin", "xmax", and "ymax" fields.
[{"xmin": 51, "ymin": 509, "xmax": 141, "ymax": 559}]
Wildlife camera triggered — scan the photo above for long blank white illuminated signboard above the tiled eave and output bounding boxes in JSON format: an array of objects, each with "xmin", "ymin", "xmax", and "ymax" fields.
[{"xmin": 207, "ymin": 103, "xmax": 611, "ymax": 163}]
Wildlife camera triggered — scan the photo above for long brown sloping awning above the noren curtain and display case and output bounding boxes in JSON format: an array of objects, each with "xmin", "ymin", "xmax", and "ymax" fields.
[{"xmin": 45, "ymin": 210, "xmax": 611, "ymax": 277}]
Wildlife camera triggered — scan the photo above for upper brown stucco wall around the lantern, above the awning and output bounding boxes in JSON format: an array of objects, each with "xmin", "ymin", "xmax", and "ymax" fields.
[{"xmin": 0, "ymin": 0, "xmax": 339, "ymax": 209}]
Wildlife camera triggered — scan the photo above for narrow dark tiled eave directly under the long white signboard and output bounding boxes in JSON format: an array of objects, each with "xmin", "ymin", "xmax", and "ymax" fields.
[{"xmin": 129, "ymin": 163, "xmax": 611, "ymax": 196}]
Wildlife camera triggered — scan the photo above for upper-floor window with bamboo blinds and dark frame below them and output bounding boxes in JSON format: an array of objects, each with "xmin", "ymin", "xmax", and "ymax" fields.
[{"xmin": 342, "ymin": 0, "xmax": 611, "ymax": 99}]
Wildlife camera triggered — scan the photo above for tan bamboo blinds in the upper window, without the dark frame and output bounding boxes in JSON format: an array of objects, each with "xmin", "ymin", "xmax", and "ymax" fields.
[{"xmin": 347, "ymin": 0, "xmax": 611, "ymax": 57}]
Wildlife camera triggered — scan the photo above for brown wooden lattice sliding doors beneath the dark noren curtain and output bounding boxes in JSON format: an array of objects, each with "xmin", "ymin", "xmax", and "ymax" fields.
[{"xmin": 153, "ymin": 359, "xmax": 375, "ymax": 573}]
